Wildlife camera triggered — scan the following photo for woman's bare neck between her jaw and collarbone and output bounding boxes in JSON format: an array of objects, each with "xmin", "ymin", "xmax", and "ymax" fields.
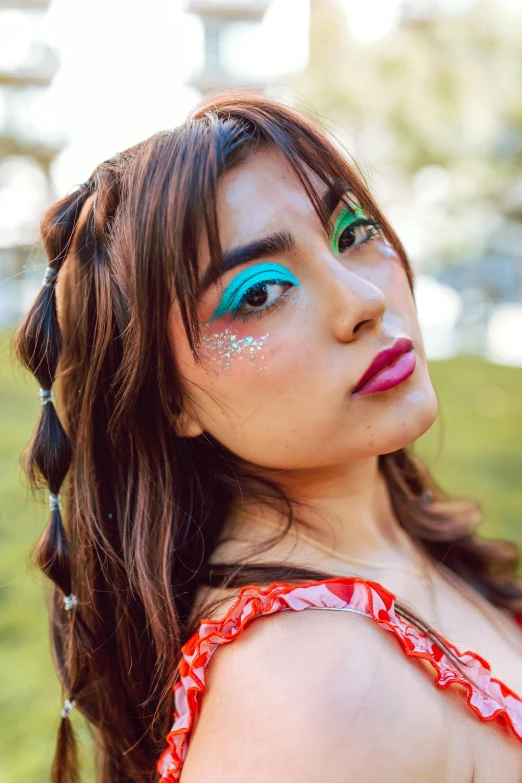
[{"xmin": 231, "ymin": 457, "xmax": 406, "ymax": 559}]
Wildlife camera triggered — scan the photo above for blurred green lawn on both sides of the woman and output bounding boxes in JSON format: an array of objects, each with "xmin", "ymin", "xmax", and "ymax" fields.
[{"xmin": 0, "ymin": 335, "xmax": 522, "ymax": 783}]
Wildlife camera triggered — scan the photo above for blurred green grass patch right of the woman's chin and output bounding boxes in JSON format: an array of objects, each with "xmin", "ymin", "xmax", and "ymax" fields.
[{"xmin": 415, "ymin": 357, "xmax": 522, "ymax": 546}]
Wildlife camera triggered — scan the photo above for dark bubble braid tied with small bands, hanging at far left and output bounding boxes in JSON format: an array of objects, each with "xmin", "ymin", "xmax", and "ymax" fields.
[{"xmin": 16, "ymin": 181, "xmax": 92, "ymax": 783}]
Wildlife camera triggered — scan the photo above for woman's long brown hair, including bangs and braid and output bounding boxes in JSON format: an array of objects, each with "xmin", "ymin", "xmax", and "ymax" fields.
[{"xmin": 15, "ymin": 93, "xmax": 522, "ymax": 783}]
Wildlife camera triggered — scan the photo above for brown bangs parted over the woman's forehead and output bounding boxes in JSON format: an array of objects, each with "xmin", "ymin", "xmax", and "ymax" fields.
[{"xmin": 156, "ymin": 96, "xmax": 412, "ymax": 363}]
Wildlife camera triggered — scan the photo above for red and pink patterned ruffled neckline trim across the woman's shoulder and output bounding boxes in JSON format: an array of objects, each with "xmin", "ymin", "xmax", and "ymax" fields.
[{"xmin": 157, "ymin": 577, "xmax": 522, "ymax": 783}]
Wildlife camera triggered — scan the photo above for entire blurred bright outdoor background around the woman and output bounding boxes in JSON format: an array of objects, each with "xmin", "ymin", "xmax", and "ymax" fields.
[{"xmin": 0, "ymin": 0, "xmax": 522, "ymax": 783}]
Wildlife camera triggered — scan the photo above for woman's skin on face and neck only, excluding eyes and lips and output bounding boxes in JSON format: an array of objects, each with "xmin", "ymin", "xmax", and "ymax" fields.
[{"xmin": 169, "ymin": 149, "xmax": 437, "ymax": 559}]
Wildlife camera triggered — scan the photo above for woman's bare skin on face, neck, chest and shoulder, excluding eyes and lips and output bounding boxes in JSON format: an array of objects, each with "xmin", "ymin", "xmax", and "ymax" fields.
[{"xmin": 169, "ymin": 145, "xmax": 522, "ymax": 783}]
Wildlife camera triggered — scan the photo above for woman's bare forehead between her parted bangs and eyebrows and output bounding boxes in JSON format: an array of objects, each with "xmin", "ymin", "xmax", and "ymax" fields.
[{"xmin": 217, "ymin": 148, "xmax": 320, "ymax": 248}]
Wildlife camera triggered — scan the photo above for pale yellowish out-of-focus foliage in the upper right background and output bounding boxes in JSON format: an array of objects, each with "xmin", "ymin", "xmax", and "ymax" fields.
[{"xmin": 291, "ymin": 0, "xmax": 522, "ymax": 260}]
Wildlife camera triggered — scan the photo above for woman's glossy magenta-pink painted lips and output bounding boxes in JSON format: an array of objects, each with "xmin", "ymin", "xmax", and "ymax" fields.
[{"xmin": 352, "ymin": 337, "xmax": 416, "ymax": 396}]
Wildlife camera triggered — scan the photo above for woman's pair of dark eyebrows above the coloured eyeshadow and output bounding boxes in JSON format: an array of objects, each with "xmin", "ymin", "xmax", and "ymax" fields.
[{"xmin": 199, "ymin": 188, "xmax": 346, "ymax": 296}]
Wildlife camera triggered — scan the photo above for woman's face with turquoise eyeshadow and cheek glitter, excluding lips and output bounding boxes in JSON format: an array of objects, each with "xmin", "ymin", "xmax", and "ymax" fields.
[{"xmin": 169, "ymin": 149, "xmax": 437, "ymax": 469}]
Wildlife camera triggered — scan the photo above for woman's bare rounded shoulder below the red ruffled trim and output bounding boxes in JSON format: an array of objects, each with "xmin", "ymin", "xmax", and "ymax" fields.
[{"xmin": 181, "ymin": 609, "xmax": 460, "ymax": 783}]
